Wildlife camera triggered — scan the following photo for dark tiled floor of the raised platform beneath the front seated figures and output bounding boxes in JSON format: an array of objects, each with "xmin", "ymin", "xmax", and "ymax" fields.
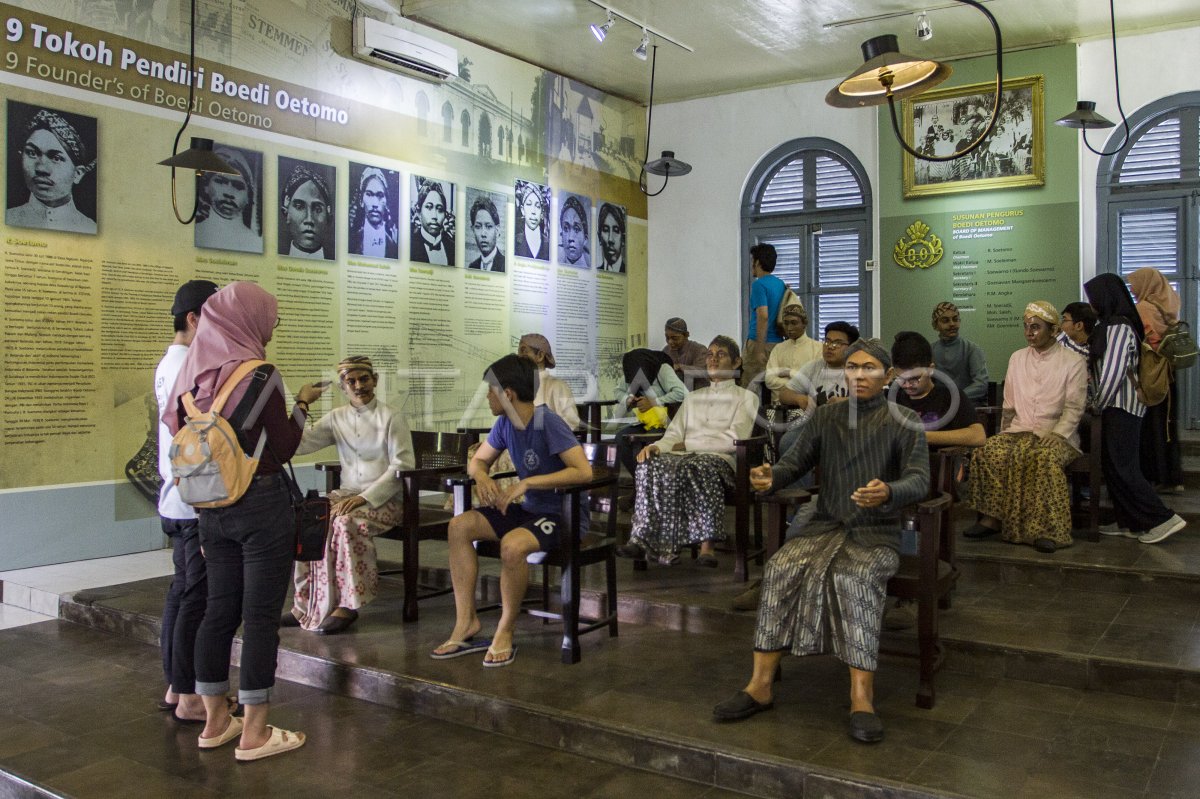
[{"xmin": 46, "ymin": 569, "xmax": 1200, "ymax": 799}]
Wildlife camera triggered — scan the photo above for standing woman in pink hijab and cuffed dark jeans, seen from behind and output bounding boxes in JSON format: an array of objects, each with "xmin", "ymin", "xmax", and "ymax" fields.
[{"xmin": 162, "ymin": 282, "xmax": 323, "ymax": 761}]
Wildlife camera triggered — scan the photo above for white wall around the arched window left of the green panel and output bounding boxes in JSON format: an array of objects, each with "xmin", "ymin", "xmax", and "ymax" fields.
[{"xmin": 647, "ymin": 80, "xmax": 878, "ymax": 348}]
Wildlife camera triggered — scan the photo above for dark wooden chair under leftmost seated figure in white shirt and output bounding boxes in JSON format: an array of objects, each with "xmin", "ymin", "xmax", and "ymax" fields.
[{"xmin": 317, "ymin": 431, "xmax": 472, "ymax": 621}]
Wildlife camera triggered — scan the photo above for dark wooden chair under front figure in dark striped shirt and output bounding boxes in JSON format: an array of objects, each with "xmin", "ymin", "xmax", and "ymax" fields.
[{"xmin": 760, "ymin": 483, "xmax": 959, "ymax": 709}]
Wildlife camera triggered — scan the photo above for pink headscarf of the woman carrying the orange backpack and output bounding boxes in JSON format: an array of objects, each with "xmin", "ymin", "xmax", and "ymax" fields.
[{"xmin": 162, "ymin": 281, "xmax": 278, "ymax": 433}]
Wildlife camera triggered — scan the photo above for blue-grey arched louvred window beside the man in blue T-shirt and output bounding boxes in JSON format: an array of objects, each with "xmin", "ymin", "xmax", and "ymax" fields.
[{"xmin": 742, "ymin": 138, "xmax": 871, "ymax": 338}]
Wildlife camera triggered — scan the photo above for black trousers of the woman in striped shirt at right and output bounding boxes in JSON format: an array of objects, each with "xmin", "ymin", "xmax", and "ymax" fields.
[{"xmin": 1100, "ymin": 408, "xmax": 1174, "ymax": 533}]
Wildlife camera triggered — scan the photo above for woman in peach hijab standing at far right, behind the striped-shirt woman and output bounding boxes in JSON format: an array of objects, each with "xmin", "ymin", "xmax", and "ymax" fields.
[{"xmin": 1129, "ymin": 266, "xmax": 1183, "ymax": 494}]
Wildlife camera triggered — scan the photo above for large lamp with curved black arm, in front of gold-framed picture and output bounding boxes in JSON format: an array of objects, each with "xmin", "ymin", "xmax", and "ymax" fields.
[{"xmin": 826, "ymin": 0, "xmax": 1004, "ymax": 161}]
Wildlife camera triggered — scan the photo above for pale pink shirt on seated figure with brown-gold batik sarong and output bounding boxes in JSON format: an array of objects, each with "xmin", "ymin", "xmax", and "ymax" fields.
[{"xmin": 1003, "ymin": 342, "xmax": 1087, "ymax": 450}]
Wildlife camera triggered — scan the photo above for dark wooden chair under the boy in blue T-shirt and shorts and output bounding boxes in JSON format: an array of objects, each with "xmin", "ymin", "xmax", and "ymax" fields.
[{"xmin": 448, "ymin": 441, "xmax": 619, "ymax": 665}]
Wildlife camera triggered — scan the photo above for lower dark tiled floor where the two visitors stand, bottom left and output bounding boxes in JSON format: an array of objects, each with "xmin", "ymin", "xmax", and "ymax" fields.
[{"xmin": 0, "ymin": 621, "xmax": 739, "ymax": 799}]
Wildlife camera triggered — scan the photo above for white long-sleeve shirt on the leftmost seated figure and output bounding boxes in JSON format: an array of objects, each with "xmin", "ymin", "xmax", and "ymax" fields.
[{"xmin": 296, "ymin": 397, "xmax": 416, "ymax": 507}]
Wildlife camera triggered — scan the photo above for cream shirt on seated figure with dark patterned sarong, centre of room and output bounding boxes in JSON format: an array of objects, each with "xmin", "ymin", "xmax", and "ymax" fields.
[{"xmin": 655, "ymin": 380, "xmax": 758, "ymax": 467}]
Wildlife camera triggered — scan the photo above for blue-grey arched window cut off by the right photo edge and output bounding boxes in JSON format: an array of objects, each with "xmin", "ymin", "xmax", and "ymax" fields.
[{"xmin": 1096, "ymin": 91, "xmax": 1200, "ymax": 428}]
